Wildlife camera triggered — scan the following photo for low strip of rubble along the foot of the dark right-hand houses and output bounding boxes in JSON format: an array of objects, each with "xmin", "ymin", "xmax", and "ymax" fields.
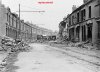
[{"xmin": 56, "ymin": 41, "xmax": 100, "ymax": 50}]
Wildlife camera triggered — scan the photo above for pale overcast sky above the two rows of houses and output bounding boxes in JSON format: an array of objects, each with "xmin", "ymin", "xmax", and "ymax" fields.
[{"xmin": 2, "ymin": 0, "xmax": 83, "ymax": 31}]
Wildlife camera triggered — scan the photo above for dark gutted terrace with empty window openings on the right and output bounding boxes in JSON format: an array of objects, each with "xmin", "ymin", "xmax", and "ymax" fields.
[{"xmin": 59, "ymin": 0, "xmax": 100, "ymax": 44}]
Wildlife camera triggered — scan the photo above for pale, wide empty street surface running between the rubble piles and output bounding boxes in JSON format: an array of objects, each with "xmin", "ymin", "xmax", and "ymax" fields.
[{"xmin": 14, "ymin": 43, "xmax": 100, "ymax": 72}]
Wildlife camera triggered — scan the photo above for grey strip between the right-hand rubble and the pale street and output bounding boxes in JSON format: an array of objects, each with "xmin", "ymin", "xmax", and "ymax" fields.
[{"xmin": 49, "ymin": 43, "xmax": 100, "ymax": 58}]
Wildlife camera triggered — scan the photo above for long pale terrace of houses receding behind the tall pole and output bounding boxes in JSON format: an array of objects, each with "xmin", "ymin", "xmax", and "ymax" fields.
[{"xmin": 0, "ymin": 2, "xmax": 52, "ymax": 41}]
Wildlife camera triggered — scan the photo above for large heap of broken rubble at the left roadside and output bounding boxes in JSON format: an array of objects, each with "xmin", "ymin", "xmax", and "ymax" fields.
[{"xmin": 0, "ymin": 37, "xmax": 29, "ymax": 72}]
